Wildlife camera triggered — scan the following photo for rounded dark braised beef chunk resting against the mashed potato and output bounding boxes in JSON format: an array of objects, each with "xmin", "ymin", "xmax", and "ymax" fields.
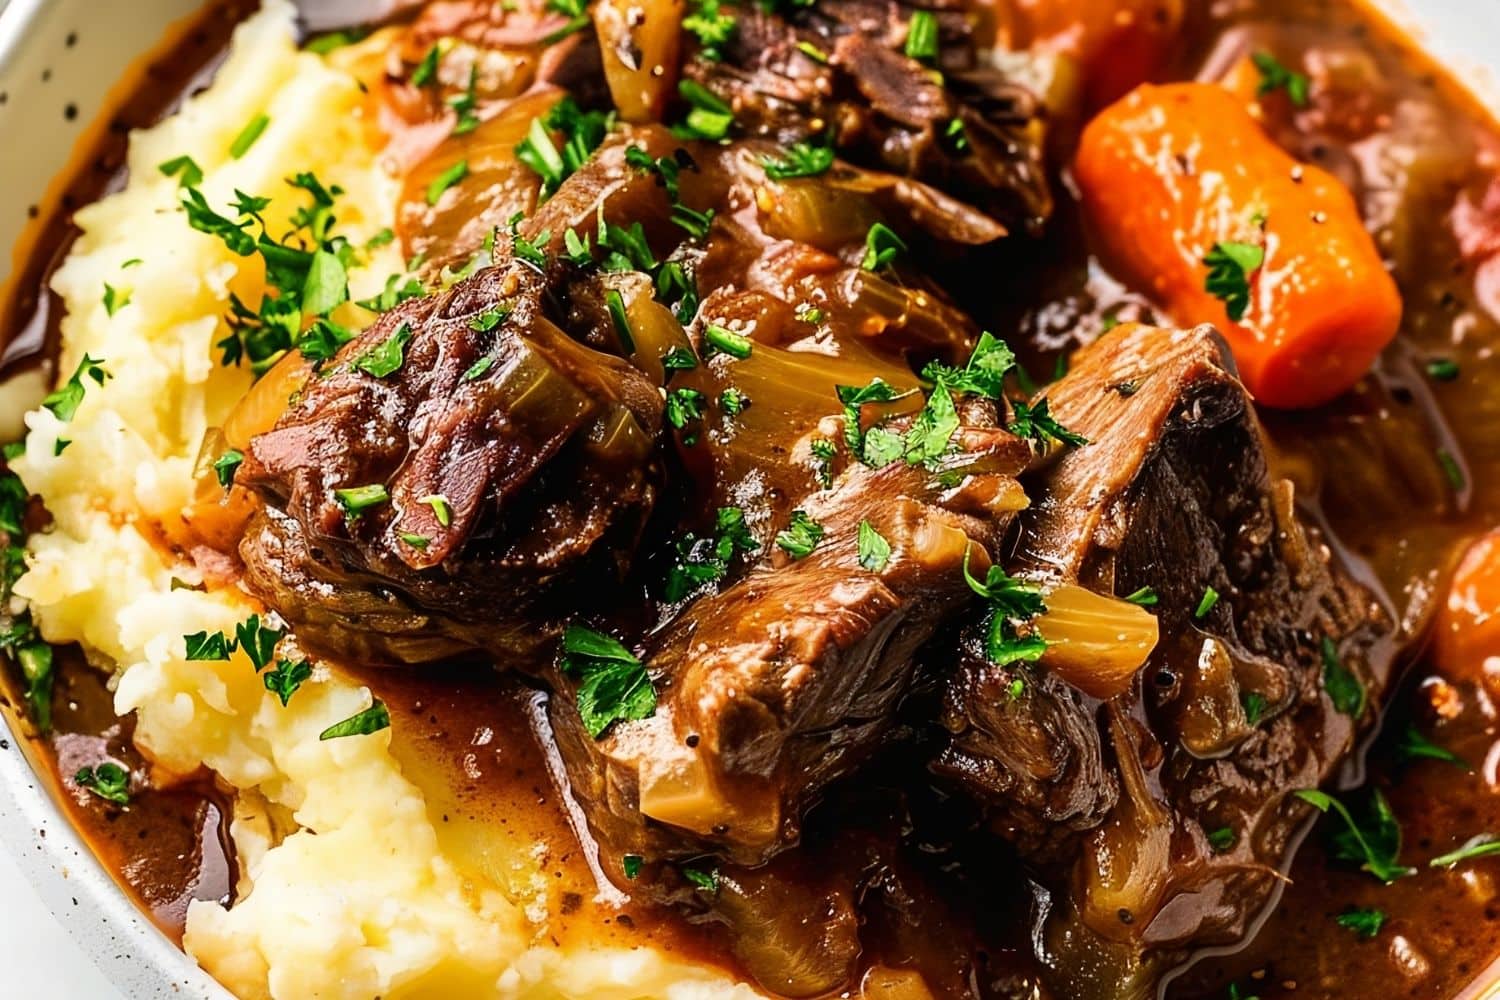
[{"xmin": 237, "ymin": 259, "xmax": 662, "ymax": 663}]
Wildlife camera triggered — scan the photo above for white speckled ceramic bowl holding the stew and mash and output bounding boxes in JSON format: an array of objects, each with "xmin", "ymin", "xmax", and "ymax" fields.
[{"xmin": 0, "ymin": 0, "xmax": 1500, "ymax": 1000}]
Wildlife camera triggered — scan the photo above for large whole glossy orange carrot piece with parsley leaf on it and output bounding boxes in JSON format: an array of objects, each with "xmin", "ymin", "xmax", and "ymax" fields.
[{"xmin": 1074, "ymin": 84, "xmax": 1401, "ymax": 408}]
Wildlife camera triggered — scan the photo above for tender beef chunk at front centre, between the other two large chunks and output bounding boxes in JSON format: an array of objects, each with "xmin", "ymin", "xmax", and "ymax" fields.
[{"xmin": 552, "ymin": 427, "xmax": 1029, "ymax": 864}]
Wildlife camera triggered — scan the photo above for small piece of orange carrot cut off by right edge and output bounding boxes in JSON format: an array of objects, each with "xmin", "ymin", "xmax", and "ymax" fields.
[{"xmin": 1433, "ymin": 528, "xmax": 1500, "ymax": 681}]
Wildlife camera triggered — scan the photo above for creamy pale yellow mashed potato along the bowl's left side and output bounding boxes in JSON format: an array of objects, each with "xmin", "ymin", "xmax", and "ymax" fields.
[{"xmin": 15, "ymin": 1, "xmax": 753, "ymax": 999}]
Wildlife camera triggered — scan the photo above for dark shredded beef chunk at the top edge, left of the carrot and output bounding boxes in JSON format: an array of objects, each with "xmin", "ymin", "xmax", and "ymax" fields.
[{"xmin": 684, "ymin": 0, "xmax": 1052, "ymax": 238}]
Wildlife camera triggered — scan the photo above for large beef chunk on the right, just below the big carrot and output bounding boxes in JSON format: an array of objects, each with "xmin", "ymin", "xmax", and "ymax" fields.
[{"xmin": 936, "ymin": 327, "xmax": 1391, "ymax": 997}]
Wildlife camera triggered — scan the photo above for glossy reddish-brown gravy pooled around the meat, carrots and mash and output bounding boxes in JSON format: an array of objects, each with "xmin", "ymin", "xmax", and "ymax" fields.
[{"xmin": 0, "ymin": 0, "xmax": 1500, "ymax": 999}]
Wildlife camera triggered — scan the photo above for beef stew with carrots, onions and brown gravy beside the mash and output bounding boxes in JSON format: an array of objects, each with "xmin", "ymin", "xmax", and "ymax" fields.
[{"xmin": 0, "ymin": 0, "xmax": 1500, "ymax": 1000}]
